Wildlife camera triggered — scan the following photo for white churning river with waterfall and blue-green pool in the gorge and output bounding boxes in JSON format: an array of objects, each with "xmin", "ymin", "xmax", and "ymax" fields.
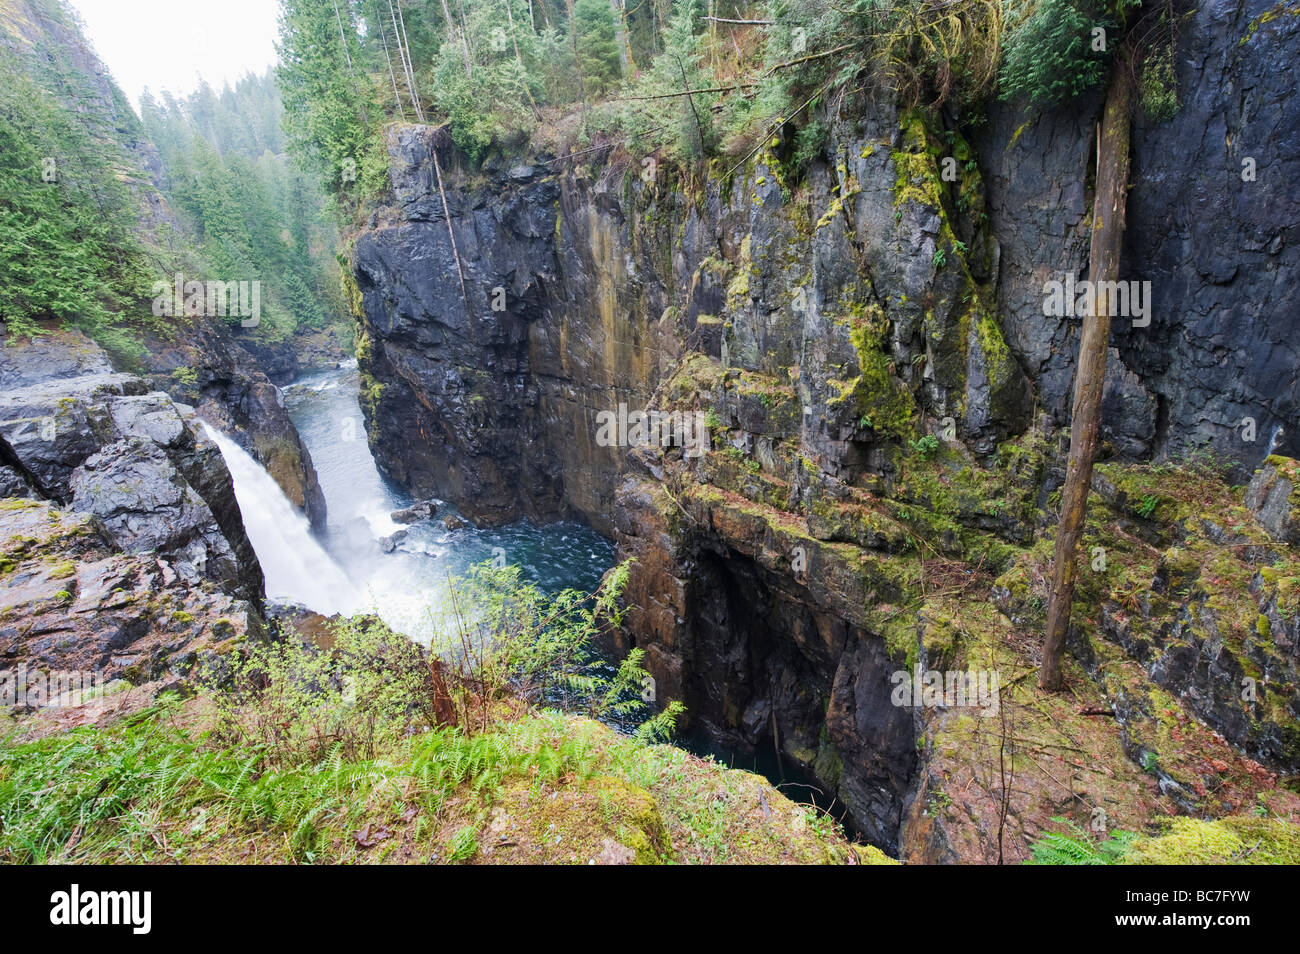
[{"xmin": 215, "ymin": 361, "xmax": 614, "ymax": 638}]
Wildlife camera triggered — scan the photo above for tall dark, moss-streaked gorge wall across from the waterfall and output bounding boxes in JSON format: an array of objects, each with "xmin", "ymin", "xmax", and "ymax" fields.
[{"xmin": 354, "ymin": 4, "xmax": 1300, "ymax": 860}]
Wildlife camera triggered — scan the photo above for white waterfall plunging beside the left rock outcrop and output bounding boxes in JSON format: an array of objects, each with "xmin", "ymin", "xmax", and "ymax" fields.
[{"xmin": 203, "ymin": 422, "xmax": 361, "ymax": 616}]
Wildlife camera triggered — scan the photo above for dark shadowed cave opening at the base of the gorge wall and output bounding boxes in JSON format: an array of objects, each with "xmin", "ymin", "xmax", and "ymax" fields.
[{"xmin": 679, "ymin": 547, "xmax": 917, "ymax": 853}]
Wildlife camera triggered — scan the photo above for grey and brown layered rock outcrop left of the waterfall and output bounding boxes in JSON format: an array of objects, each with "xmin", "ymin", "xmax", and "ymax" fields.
[{"xmin": 0, "ymin": 333, "xmax": 264, "ymax": 711}]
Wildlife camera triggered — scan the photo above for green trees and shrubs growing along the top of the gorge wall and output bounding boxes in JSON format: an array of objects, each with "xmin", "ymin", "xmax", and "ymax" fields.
[{"xmin": 280, "ymin": 0, "xmax": 1171, "ymax": 201}]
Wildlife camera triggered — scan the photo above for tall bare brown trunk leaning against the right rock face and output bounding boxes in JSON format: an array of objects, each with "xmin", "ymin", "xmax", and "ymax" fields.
[{"xmin": 1039, "ymin": 59, "xmax": 1132, "ymax": 690}]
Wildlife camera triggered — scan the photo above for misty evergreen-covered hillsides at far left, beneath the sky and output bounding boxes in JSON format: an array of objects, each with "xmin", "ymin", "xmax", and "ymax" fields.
[{"xmin": 0, "ymin": 0, "xmax": 343, "ymax": 365}]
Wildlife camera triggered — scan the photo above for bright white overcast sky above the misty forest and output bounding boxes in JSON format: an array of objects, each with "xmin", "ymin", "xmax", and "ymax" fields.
[{"xmin": 69, "ymin": 0, "xmax": 280, "ymax": 109}]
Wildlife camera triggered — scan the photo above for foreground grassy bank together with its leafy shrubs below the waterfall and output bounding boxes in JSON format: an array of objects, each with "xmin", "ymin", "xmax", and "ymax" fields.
[{"xmin": 0, "ymin": 567, "xmax": 868, "ymax": 864}]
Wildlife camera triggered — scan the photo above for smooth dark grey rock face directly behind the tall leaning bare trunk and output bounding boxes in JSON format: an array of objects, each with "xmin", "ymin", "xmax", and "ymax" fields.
[{"xmin": 979, "ymin": 0, "xmax": 1300, "ymax": 474}]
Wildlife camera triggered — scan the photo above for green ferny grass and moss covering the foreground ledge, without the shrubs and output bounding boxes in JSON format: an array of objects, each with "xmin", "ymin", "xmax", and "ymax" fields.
[{"xmin": 0, "ymin": 695, "xmax": 868, "ymax": 863}]
